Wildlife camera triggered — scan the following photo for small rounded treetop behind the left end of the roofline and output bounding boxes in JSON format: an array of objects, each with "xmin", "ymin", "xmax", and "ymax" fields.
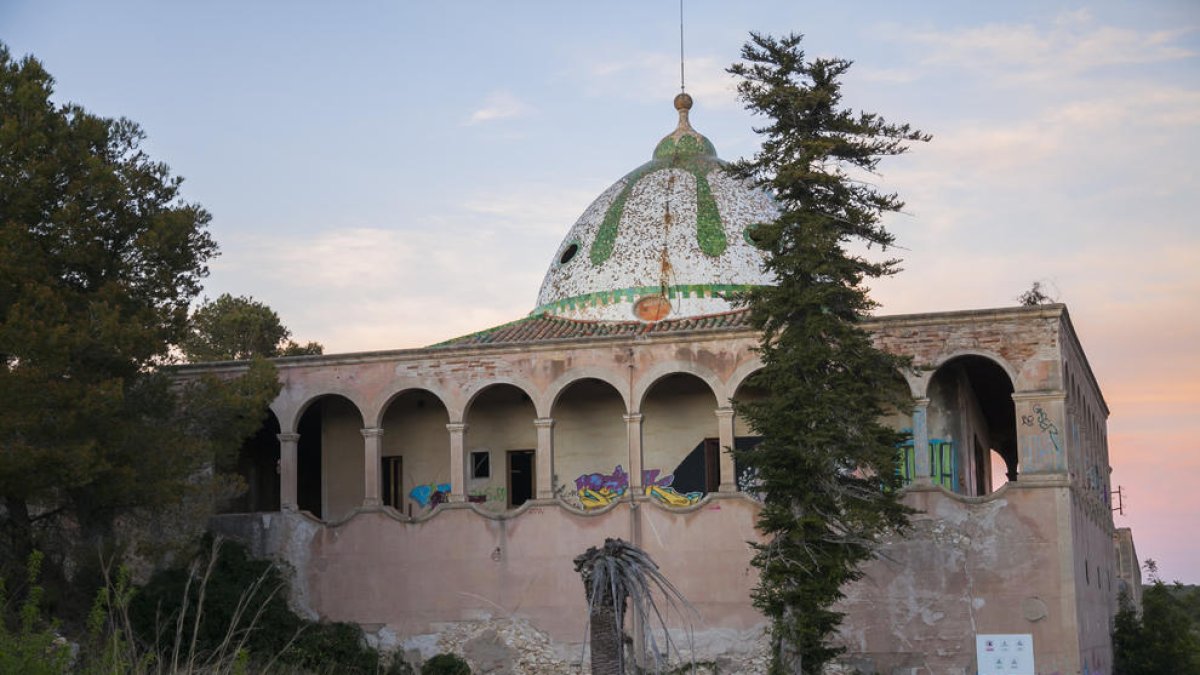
[{"xmin": 180, "ymin": 293, "xmax": 324, "ymax": 362}]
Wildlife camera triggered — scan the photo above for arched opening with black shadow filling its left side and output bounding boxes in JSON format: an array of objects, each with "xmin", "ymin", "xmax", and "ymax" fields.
[{"xmin": 295, "ymin": 392, "xmax": 365, "ymax": 520}]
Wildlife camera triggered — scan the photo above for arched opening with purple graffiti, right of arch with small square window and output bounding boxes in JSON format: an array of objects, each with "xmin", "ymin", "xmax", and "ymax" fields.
[{"xmin": 551, "ymin": 377, "xmax": 631, "ymax": 509}]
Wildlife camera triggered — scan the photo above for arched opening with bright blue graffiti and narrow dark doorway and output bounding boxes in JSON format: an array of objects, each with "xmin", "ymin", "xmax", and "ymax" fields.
[{"xmin": 376, "ymin": 387, "xmax": 451, "ymax": 516}]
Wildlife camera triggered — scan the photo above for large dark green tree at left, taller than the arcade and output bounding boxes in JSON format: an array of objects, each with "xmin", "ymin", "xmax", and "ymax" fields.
[{"xmin": 0, "ymin": 44, "xmax": 277, "ymax": 590}]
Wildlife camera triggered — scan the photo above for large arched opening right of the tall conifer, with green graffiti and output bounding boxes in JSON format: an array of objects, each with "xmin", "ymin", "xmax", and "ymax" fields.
[{"xmin": 925, "ymin": 351, "xmax": 1019, "ymax": 496}]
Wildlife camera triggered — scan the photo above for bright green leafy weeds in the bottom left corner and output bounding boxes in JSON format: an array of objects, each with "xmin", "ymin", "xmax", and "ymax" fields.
[{"xmin": 0, "ymin": 551, "xmax": 71, "ymax": 675}]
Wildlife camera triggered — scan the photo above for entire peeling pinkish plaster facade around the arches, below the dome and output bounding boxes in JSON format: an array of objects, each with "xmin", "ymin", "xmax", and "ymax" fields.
[{"xmin": 196, "ymin": 305, "xmax": 1117, "ymax": 674}]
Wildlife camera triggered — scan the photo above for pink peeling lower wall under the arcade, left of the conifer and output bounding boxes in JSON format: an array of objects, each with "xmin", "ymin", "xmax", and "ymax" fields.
[{"xmin": 216, "ymin": 495, "xmax": 764, "ymax": 655}]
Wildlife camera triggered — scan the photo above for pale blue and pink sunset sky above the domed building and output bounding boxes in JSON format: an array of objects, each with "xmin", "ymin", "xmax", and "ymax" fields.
[{"xmin": 0, "ymin": 0, "xmax": 1200, "ymax": 584}]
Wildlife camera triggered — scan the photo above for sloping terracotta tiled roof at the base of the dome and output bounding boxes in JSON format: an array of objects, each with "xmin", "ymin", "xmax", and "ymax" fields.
[{"xmin": 432, "ymin": 309, "xmax": 750, "ymax": 348}]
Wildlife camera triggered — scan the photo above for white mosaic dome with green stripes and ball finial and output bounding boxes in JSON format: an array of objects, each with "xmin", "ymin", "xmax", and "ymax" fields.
[{"xmin": 533, "ymin": 94, "xmax": 779, "ymax": 321}]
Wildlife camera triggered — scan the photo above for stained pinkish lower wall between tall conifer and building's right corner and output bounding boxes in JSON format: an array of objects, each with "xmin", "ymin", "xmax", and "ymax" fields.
[{"xmin": 840, "ymin": 483, "xmax": 1080, "ymax": 674}]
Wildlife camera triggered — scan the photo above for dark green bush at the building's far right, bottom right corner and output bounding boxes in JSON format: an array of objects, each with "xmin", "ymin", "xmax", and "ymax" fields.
[{"xmin": 1112, "ymin": 560, "xmax": 1200, "ymax": 675}]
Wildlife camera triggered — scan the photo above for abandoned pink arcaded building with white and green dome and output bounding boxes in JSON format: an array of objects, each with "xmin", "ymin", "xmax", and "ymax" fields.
[{"xmin": 194, "ymin": 95, "xmax": 1136, "ymax": 674}]
